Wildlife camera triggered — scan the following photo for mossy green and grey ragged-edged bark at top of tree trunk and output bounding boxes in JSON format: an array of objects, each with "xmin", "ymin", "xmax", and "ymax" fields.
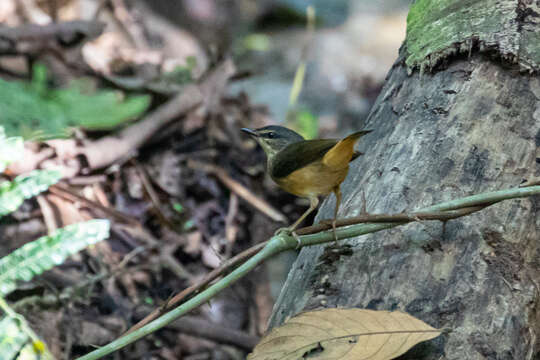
[{"xmin": 405, "ymin": 0, "xmax": 540, "ymax": 72}]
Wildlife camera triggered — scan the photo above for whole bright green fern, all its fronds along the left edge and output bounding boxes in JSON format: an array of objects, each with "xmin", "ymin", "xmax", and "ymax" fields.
[{"xmin": 0, "ymin": 127, "xmax": 109, "ymax": 360}]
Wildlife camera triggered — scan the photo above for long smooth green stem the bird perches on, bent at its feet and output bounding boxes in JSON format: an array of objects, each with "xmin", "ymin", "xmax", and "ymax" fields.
[{"xmin": 75, "ymin": 186, "xmax": 540, "ymax": 360}]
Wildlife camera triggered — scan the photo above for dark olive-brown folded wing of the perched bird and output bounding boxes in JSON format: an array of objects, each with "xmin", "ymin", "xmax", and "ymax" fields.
[{"xmin": 270, "ymin": 139, "xmax": 339, "ymax": 178}]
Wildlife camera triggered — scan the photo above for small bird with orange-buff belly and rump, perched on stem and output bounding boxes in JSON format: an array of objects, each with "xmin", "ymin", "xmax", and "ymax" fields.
[{"xmin": 241, "ymin": 125, "xmax": 372, "ymax": 241}]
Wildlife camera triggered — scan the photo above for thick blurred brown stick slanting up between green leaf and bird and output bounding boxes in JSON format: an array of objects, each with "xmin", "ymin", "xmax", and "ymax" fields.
[{"xmin": 79, "ymin": 59, "xmax": 235, "ymax": 169}]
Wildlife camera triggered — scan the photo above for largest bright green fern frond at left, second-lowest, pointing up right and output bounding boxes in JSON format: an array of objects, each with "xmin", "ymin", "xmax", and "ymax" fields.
[{"xmin": 0, "ymin": 220, "xmax": 110, "ymax": 296}]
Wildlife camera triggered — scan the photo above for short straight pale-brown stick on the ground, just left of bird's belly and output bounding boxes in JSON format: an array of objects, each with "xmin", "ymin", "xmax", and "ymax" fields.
[{"xmin": 188, "ymin": 160, "xmax": 287, "ymax": 222}]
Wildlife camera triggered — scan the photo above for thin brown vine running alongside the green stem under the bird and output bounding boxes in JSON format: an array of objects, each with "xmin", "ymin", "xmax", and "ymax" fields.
[{"xmin": 126, "ymin": 205, "xmax": 489, "ymax": 334}]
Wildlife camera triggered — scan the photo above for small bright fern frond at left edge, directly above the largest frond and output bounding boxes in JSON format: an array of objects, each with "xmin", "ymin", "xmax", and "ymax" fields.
[{"xmin": 0, "ymin": 170, "xmax": 62, "ymax": 217}]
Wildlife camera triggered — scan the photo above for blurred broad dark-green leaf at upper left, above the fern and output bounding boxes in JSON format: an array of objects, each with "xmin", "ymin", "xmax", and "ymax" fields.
[{"xmin": 0, "ymin": 65, "xmax": 150, "ymax": 140}]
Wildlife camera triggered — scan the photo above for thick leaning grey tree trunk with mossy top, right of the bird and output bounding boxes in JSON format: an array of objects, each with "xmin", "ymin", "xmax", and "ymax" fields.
[{"xmin": 270, "ymin": 0, "xmax": 540, "ymax": 360}]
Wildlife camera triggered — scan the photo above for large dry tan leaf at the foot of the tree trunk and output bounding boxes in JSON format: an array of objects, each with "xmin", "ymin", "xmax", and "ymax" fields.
[{"xmin": 248, "ymin": 309, "xmax": 441, "ymax": 360}]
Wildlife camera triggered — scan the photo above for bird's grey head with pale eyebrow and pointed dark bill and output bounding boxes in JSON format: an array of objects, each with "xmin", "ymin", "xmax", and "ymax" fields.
[{"xmin": 242, "ymin": 125, "xmax": 304, "ymax": 158}]
